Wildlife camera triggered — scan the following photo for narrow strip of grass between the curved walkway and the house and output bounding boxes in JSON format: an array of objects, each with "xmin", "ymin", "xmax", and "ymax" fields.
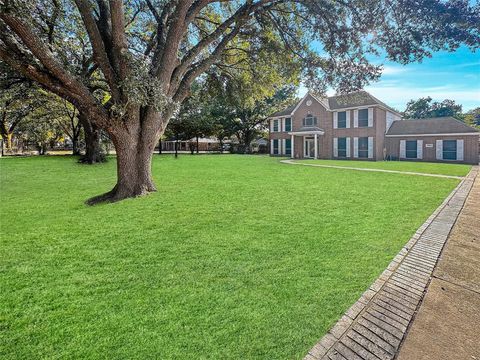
[{"xmin": 295, "ymin": 159, "xmax": 471, "ymax": 176}]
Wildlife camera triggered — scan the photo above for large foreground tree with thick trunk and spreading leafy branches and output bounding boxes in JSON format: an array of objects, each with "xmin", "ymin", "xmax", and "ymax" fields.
[{"xmin": 0, "ymin": 0, "xmax": 480, "ymax": 203}]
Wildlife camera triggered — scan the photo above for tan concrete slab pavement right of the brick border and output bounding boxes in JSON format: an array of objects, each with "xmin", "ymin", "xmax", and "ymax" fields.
[{"xmin": 397, "ymin": 176, "xmax": 480, "ymax": 360}]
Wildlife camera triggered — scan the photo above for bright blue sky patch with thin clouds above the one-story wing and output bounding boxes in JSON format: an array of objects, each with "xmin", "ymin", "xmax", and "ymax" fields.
[{"xmin": 300, "ymin": 47, "xmax": 480, "ymax": 111}]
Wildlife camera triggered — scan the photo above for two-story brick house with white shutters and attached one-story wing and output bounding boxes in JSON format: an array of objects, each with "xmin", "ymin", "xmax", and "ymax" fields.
[{"xmin": 269, "ymin": 91, "xmax": 479, "ymax": 164}]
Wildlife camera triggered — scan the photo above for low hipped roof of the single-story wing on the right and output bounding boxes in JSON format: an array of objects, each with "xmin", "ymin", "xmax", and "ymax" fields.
[{"xmin": 387, "ymin": 116, "xmax": 478, "ymax": 136}]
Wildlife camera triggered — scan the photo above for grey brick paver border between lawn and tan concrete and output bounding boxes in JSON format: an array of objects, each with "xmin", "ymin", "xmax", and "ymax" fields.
[{"xmin": 304, "ymin": 166, "xmax": 480, "ymax": 360}]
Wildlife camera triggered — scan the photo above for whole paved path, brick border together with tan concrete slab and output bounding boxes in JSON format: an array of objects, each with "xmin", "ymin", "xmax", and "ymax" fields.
[{"xmin": 304, "ymin": 166, "xmax": 480, "ymax": 360}]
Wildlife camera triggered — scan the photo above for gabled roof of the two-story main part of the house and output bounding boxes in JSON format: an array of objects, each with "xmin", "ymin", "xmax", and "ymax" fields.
[{"xmin": 270, "ymin": 90, "xmax": 398, "ymax": 117}]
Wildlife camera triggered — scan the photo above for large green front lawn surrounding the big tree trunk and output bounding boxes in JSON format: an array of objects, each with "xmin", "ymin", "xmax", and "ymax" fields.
[{"xmin": 0, "ymin": 155, "xmax": 467, "ymax": 359}]
